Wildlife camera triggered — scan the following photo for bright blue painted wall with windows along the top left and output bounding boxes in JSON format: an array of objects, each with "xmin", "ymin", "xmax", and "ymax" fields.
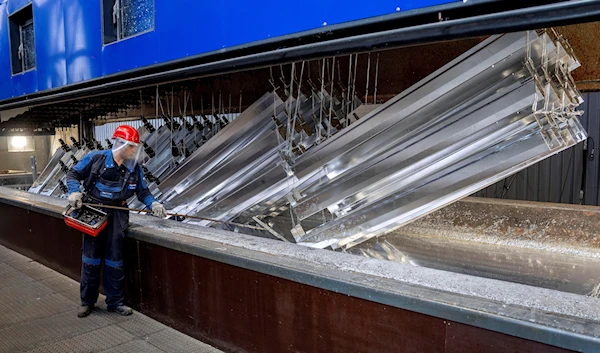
[{"xmin": 0, "ymin": 0, "xmax": 461, "ymax": 101}]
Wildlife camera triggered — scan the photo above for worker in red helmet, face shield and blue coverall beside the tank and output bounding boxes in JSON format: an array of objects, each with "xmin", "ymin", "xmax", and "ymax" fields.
[{"xmin": 67, "ymin": 125, "xmax": 167, "ymax": 317}]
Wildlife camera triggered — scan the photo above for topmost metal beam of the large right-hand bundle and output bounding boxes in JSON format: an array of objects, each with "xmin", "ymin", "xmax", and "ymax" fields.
[{"xmin": 294, "ymin": 33, "xmax": 525, "ymax": 178}]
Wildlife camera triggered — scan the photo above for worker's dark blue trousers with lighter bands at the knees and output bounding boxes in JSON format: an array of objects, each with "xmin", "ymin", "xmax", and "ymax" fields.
[{"xmin": 80, "ymin": 209, "xmax": 129, "ymax": 309}]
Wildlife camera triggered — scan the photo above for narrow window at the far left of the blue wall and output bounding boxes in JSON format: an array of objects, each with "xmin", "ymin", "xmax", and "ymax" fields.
[{"xmin": 8, "ymin": 4, "xmax": 35, "ymax": 75}]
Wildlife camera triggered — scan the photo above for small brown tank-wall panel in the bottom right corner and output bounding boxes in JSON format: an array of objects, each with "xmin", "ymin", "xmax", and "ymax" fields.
[{"xmin": 446, "ymin": 322, "xmax": 571, "ymax": 353}]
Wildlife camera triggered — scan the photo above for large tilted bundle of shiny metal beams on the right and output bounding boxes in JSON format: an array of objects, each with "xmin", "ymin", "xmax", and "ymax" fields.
[{"xmin": 284, "ymin": 32, "xmax": 586, "ymax": 247}]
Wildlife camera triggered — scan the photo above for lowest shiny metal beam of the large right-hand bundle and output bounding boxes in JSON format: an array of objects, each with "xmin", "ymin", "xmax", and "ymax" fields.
[{"xmin": 303, "ymin": 131, "xmax": 553, "ymax": 247}]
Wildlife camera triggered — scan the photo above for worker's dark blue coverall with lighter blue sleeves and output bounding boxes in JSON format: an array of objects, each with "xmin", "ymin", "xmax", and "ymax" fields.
[{"xmin": 67, "ymin": 150, "xmax": 156, "ymax": 309}]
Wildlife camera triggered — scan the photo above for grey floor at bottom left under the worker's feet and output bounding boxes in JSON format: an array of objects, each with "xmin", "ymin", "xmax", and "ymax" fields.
[{"xmin": 0, "ymin": 246, "xmax": 220, "ymax": 353}]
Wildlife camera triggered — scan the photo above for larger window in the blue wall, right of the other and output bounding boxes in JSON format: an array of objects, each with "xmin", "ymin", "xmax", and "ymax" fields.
[{"xmin": 102, "ymin": 0, "xmax": 154, "ymax": 44}]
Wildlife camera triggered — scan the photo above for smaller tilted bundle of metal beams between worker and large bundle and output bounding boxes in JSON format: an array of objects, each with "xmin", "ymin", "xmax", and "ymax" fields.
[{"xmin": 159, "ymin": 88, "xmax": 359, "ymax": 224}]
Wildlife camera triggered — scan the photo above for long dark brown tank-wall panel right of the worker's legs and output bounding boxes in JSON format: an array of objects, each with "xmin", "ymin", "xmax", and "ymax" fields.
[{"xmin": 128, "ymin": 240, "xmax": 445, "ymax": 352}]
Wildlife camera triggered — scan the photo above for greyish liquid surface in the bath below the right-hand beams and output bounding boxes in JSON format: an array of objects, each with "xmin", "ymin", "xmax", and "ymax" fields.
[{"xmin": 350, "ymin": 231, "xmax": 600, "ymax": 295}]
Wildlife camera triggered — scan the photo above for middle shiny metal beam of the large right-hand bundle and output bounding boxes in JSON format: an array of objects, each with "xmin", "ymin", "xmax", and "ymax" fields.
[{"xmin": 294, "ymin": 82, "xmax": 535, "ymax": 219}]
